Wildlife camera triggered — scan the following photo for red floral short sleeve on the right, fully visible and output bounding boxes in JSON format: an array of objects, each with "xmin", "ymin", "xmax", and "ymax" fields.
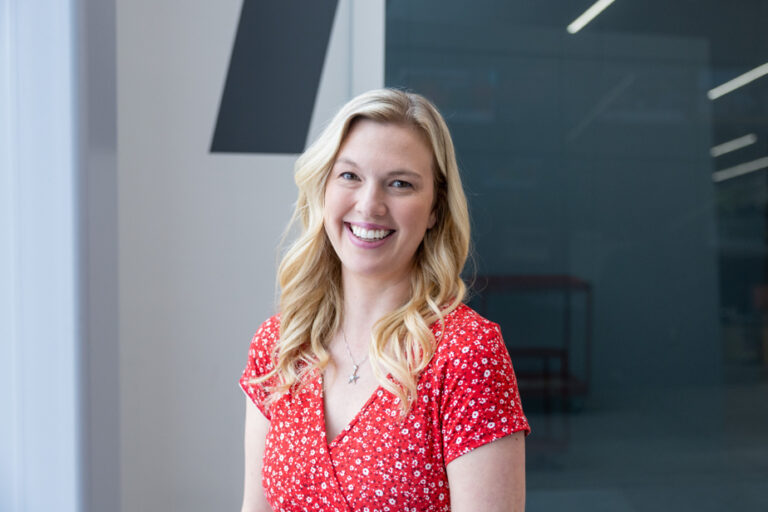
[{"xmin": 441, "ymin": 319, "xmax": 531, "ymax": 464}]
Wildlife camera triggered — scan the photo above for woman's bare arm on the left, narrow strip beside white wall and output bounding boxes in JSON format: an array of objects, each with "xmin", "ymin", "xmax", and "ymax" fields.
[{"xmin": 241, "ymin": 397, "xmax": 272, "ymax": 512}]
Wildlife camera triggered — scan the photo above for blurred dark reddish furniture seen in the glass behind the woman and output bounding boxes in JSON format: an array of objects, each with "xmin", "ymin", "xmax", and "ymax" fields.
[{"xmin": 475, "ymin": 275, "xmax": 592, "ymax": 412}]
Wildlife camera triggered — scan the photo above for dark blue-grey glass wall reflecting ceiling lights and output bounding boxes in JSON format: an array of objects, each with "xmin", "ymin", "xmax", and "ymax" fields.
[{"xmin": 386, "ymin": 0, "xmax": 768, "ymax": 512}]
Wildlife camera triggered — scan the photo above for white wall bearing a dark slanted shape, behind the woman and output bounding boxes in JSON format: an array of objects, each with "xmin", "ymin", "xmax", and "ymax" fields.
[{"xmin": 117, "ymin": 0, "xmax": 384, "ymax": 512}]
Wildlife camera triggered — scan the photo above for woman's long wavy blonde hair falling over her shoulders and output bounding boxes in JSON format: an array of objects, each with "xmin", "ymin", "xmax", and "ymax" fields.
[{"xmin": 254, "ymin": 89, "xmax": 470, "ymax": 415}]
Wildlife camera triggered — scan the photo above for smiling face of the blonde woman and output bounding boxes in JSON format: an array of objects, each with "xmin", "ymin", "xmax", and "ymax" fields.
[{"xmin": 323, "ymin": 119, "xmax": 435, "ymax": 284}]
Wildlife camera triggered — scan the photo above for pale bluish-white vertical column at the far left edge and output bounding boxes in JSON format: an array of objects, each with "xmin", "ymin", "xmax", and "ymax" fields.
[{"xmin": 0, "ymin": 0, "xmax": 81, "ymax": 512}]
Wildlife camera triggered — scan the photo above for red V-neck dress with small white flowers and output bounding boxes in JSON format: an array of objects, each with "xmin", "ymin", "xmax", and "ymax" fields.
[{"xmin": 240, "ymin": 305, "xmax": 530, "ymax": 512}]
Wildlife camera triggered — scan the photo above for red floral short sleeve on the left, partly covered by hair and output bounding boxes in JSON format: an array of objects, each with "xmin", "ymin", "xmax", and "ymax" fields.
[{"xmin": 240, "ymin": 316, "xmax": 280, "ymax": 419}]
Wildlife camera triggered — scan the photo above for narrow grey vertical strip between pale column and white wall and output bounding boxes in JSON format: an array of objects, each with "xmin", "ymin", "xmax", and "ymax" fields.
[{"xmin": 76, "ymin": 0, "xmax": 120, "ymax": 511}]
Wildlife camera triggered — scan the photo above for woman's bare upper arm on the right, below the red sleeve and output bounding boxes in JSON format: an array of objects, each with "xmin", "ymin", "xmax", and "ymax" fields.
[{"xmin": 447, "ymin": 432, "xmax": 525, "ymax": 512}]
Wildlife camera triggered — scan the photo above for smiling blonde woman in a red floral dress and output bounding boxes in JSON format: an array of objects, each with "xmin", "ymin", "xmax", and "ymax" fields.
[{"xmin": 240, "ymin": 89, "xmax": 530, "ymax": 512}]
